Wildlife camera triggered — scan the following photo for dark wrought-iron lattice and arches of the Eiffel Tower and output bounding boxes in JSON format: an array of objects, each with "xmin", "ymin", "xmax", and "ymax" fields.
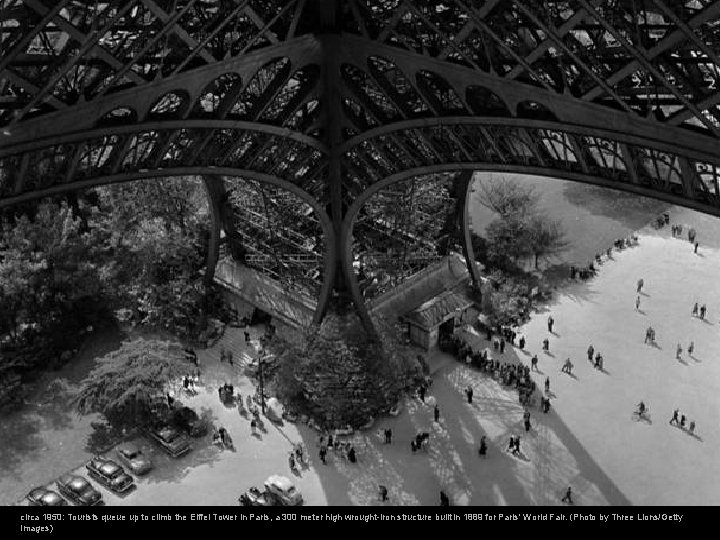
[{"xmin": 0, "ymin": 0, "xmax": 720, "ymax": 326}]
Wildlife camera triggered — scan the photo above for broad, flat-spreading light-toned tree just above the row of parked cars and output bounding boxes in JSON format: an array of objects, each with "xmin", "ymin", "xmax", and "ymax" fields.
[{"xmin": 73, "ymin": 339, "xmax": 187, "ymax": 428}]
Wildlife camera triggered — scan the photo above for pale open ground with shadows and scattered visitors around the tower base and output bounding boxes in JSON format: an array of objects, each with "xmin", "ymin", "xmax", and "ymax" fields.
[{"xmin": 0, "ymin": 180, "xmax": 720, "ymax": 505}]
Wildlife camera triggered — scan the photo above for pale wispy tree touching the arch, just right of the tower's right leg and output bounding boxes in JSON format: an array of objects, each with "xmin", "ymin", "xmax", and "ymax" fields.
[{"xmin": 473, "ymin": 175, "xmax": 540, "ymax": 219}]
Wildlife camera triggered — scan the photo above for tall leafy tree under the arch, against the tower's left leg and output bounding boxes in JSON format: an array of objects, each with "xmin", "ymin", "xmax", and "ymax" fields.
[{"xmin": 91, "ymin": 177, "xmax": 209, "ymax": 337}]
